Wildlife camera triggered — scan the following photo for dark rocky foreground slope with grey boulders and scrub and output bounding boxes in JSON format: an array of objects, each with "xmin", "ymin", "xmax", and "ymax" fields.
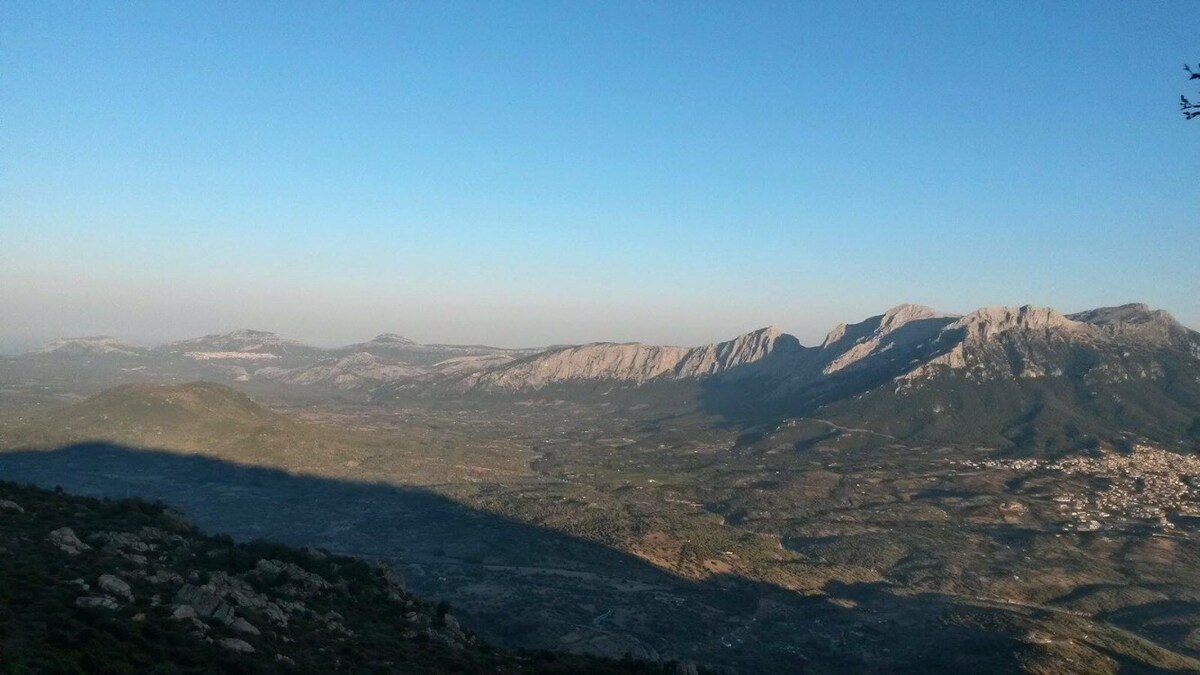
[{"xmin": 0, "ymin": 483, "xmax": 696, "ymax": 674}]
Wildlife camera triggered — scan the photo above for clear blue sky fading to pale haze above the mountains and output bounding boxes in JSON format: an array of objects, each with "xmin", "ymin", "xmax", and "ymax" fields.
[{"xmin": 0, "ymin": 0, "xmax": 1200, "ymax": 352}]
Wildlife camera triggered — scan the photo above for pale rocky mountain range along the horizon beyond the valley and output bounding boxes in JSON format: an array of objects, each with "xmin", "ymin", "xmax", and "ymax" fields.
[{"xmin": 11, "ymin": 304, "xmax": 1200, "ymax": 448}]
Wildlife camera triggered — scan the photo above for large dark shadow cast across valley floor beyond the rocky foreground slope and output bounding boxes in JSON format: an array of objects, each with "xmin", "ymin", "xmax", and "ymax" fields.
[{"xmin": 0, "ymin": 443, "xmax": 1051, "ymax": 673}]
